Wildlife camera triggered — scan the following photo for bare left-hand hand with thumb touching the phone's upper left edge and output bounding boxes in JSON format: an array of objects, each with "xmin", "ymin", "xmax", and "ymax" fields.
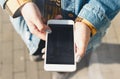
[{"xmin": 21, "ymin": 2, "xmax": 50, "ymax": 40}]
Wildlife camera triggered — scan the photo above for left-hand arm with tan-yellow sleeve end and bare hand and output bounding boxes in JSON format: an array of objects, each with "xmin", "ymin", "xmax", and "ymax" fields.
[{"xmin": 1, "ymin": 0, "xmax": 49, "ymax": 40}]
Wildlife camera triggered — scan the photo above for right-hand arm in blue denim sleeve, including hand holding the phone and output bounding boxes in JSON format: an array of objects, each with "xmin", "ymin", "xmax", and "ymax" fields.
[{"xmin": 75, "ymin": 0, "xmax": 120, "ymax": 61}]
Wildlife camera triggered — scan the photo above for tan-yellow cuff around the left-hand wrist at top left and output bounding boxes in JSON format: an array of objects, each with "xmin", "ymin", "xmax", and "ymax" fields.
[{"xmin": 5, "ymin": 0, "xmax": 32, "ymax": 18}]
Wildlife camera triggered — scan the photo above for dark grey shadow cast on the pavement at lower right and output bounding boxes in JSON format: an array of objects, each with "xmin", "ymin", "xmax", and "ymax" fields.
[{"xmin": 61, "ymin": 43, "xmax": 120, "ymax": 79}]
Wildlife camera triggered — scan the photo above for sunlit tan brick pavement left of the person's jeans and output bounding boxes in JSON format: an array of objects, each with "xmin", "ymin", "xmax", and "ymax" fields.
[{"xmin": 0, "ymin": 7, "xmax": 51, "ymax": 79}]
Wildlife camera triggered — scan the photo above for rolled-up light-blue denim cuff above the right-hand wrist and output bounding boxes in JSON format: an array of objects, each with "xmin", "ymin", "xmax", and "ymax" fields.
[{"xmin": 78, "ymin": 4, "xmax": 110, "ymax": 32}]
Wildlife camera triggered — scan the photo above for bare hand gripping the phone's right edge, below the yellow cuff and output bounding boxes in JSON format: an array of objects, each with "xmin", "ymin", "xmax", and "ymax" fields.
[{"xmin": 74, "ymin": 22, "xmax": 91, "ymax": 62}]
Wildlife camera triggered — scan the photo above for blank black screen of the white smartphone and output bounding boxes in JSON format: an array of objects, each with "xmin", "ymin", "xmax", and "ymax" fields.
[{"xmin": 46, "ymin": 24, "xmax": 74, "ymax": 64}]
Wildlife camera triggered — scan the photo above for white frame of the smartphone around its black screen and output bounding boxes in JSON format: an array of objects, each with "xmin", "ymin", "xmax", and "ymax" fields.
[{"xmin": 44, "ymin": 20, "xmax": 76, "ymax": 72}]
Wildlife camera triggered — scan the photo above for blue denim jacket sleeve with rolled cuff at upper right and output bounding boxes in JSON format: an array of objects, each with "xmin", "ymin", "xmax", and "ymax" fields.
[{"xmin": 78, "ymin": 0, "xmax": 120, "ymax": 31}]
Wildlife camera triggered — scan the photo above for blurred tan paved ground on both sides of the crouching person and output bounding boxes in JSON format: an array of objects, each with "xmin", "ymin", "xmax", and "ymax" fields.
[{"xmin": 0, "ymin": 7, "xmax": 120, "ymax": 79}]
